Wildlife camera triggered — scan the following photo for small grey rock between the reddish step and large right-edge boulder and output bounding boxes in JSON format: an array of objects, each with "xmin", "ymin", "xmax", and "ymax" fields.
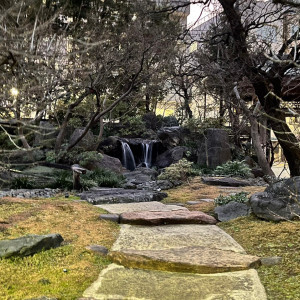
[{"xmin": 215, "ymin": 201, "xmax": 250, "ymax": 222}]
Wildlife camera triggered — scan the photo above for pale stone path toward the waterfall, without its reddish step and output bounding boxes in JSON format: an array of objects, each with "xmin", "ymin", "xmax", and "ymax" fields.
[{"xmin": 83, "ymin": 202, "xmax": 267, "ymax": 300}]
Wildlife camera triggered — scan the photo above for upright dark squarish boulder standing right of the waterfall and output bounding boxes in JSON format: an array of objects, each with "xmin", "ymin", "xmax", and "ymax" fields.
[{"xmin": 197, "ymin": 128, "xmax": 231, "ymax": 168}]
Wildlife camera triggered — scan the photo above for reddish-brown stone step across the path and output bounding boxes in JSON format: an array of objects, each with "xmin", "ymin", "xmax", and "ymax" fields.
[{"xmin": 120, "ymin": 209, "xmax": 217, "ymax": 225}]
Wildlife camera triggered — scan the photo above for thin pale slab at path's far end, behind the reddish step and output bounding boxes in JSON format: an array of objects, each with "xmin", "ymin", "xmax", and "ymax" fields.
[{"xmin": 96, "ymin": 201, "xmax": 188, "ymax": 214}]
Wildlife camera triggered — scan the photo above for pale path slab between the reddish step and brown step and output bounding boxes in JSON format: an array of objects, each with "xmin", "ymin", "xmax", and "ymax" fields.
[{"xmin": 112, "ymin": 224, "xmax": 246, "ymax": 254}]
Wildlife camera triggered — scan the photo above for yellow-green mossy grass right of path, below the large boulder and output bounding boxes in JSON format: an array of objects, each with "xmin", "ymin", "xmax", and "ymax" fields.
[{"xmin": 219, "ymin": 217, "xmax": 300, "ymax": 300}]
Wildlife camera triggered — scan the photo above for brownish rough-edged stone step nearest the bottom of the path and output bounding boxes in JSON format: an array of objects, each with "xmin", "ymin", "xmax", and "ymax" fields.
[{"xmin": 109, "ymin": 247, "xmax": 260, "ymax": 274}]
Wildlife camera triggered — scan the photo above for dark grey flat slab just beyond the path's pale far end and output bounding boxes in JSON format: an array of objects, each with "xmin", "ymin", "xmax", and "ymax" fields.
[{"xmin": 80, "ymin": 188, "xmax": 167, "ymax": 205}]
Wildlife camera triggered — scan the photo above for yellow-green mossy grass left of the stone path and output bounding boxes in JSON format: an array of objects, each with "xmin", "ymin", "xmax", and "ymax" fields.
[{"xmin": 0, "ymin": 197, "xmax": 119, "ymax": 299}]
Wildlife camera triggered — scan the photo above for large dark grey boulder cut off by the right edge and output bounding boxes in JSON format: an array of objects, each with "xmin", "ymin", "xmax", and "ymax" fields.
[{"xmin": 250, "ymin": 176, "xmax": 300, "ymax": 221}]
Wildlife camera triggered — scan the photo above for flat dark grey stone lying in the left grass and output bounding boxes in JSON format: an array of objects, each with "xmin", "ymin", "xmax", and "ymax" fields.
[{"xmin": 0, "ymin": 233, "xmax": 63, "ymax": 258}]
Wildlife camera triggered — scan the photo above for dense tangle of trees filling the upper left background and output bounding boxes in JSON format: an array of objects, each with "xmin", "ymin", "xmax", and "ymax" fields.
[{"xmin": 0, "ymin": 0, "xmax": 178, "ymax": 151}]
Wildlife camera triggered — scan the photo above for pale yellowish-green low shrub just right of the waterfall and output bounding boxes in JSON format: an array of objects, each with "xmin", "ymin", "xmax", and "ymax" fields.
[{"xmin": 158, "ymin": 158, "xmax": 193, "ymax": 181}]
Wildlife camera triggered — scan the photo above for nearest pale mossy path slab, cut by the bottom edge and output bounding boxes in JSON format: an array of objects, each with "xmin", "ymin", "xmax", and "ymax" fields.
[{"xmin": 83, "ymin": 264, "xmax": 267, "ymax": 300}]
